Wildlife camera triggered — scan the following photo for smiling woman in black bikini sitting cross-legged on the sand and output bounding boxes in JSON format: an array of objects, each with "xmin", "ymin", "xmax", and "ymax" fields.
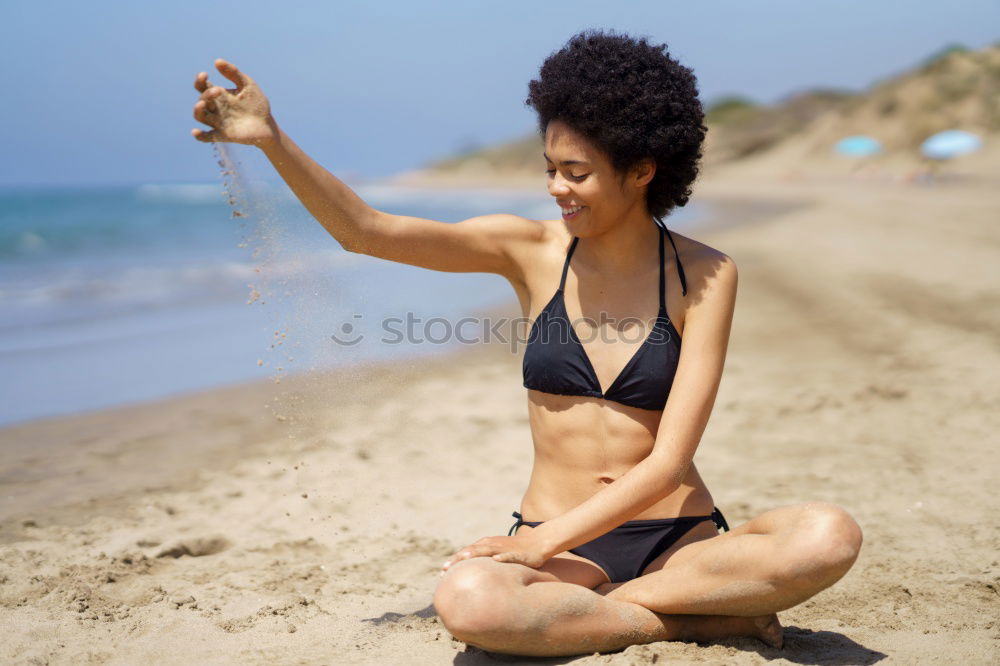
[{"xmin": 193, "ymin": 32, "xmax": 861, "ymax": 655}]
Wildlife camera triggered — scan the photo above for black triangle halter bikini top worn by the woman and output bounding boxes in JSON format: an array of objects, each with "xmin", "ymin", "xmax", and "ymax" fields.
[{"xmin": 522, "ymin": 224, "xmax": 687, "ymax": 410}]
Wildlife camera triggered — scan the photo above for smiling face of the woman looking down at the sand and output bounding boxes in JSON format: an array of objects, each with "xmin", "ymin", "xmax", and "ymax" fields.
[{"xmin": 544, "ymin": 120, "xmax": 652, "ymax": 237}]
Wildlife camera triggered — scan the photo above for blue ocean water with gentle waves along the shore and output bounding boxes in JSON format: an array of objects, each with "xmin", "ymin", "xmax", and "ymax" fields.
[{"xmin": 0, "ymin": 183, "xmax": 702, "ymax": 424}]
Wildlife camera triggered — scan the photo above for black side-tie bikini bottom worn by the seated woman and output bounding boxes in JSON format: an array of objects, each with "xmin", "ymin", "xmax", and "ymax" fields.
[{"xmin": 507, "ymin": 508, "xmax": 729, "ymax": 583}]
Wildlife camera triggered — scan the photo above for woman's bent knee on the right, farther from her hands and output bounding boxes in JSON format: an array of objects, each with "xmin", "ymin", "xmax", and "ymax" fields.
[{"xmin": 793, "ymin": 502, "xmax": 862, "ymax": 578}]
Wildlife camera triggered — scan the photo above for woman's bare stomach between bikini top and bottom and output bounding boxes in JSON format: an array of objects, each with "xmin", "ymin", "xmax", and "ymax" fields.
[{"xmin": 521, "ymin": 390, "xmax": 714, "ymax": 521}]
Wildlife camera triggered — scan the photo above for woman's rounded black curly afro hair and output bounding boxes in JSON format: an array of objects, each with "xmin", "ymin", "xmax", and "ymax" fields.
[{"xmin": 525, "ymin": 30, "xmax": 708, "ymax": 219}]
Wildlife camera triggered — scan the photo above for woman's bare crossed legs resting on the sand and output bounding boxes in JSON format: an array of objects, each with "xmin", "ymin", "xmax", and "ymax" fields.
[{"xmin": 434, "ymin": 504, "xmax": 861, "ymax": 656}]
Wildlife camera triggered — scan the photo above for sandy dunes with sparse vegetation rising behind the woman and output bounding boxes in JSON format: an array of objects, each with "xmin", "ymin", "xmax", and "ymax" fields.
[{"xmin": 410, "ymin": 43, "xmax": 1000, "ymax": 176}]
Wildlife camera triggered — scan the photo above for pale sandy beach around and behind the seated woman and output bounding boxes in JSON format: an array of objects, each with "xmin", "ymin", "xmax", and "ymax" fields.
[{"xmin": 0, "ymin": 171, "xmax": 1000, "ymax": 665}]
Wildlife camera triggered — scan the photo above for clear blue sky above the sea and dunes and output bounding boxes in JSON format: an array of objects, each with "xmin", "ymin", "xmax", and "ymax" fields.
[{"xmin": 0, "ymin": 0, "xmax": 1000, "ymax": 185}]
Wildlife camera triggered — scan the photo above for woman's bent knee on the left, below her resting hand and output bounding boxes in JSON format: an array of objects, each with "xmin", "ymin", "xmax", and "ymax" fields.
[{"xmin": 434, "ymin": 557, "xmax": 523, "ymax": 643}]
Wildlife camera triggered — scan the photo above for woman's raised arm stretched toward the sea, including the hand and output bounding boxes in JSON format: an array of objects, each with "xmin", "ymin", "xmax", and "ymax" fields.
[{"xmin": 191, "ymin": 60, "xmax": 544, "ymax": 279}]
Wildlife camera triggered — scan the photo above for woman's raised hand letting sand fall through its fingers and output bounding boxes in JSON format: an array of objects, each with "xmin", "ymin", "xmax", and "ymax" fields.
[{"xmin": 191, "ymin": 59, "xmax": 278, "ymax": 147}]
